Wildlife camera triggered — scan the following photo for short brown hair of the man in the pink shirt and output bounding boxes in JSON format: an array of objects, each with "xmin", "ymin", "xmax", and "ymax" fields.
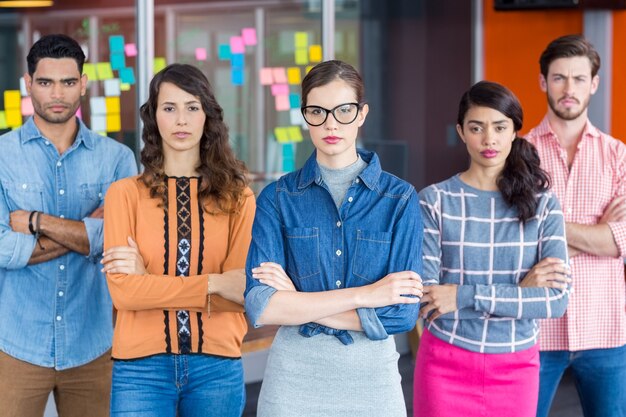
[{"xmin": 539, "ymin": 35, "xmax": 600, "ymax": 77}]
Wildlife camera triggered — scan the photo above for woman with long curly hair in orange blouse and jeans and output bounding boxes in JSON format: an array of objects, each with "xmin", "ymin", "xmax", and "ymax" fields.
[{"xmin": 102, "ymin": 64, "xmax": 255, "ymax": 417}]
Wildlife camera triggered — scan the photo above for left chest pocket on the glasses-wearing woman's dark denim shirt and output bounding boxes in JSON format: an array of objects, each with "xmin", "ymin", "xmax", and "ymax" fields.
[{"xmin": 284, "ymin": 227, "xmax": 321, "ymax": 282}]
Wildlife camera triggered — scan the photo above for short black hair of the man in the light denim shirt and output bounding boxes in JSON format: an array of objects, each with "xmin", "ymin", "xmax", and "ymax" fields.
[{"xmin": 26, "ymin": 33, "xmax": 85, "ymax": 76}]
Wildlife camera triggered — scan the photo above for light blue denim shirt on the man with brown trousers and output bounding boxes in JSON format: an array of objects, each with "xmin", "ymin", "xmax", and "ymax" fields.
[{"xmin": 0, "ymin": 118, "xmax": 137, "ymax": 370}]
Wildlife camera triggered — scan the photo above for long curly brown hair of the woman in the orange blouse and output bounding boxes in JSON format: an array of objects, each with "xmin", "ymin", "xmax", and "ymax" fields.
[{"xmin": 140, "ymin": 64, "xmax": 248, "ymax": 214}]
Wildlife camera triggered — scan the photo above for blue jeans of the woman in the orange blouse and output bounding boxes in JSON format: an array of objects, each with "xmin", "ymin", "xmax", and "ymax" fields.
[{"xmin": 111, "ymin": 354, "xmax": 246, "ymax": 417}]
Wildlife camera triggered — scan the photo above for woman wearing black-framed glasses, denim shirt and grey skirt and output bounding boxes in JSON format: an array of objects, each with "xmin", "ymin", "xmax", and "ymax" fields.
[{"xmin": 245, "ymin": 61, "xmax": 422, "ymax": 417}]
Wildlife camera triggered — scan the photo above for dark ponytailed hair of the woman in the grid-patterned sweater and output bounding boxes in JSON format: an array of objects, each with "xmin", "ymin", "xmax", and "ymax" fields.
[{"xmin": 457, "ymin": 81, "xmax": 550, "ymax": 222}]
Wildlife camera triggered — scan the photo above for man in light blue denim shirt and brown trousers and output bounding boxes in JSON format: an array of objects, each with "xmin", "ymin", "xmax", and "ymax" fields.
[{"xmin": 0, "ymin": 35, "xmax": 137, "ymax": 417}]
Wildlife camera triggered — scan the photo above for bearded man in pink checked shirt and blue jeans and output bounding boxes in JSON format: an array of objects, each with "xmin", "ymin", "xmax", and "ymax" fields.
[{"xmin": 527, "ymin": 35, "xmax": 626, "ymax": 417}]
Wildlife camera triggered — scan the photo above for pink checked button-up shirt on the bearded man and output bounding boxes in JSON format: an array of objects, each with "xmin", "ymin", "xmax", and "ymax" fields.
[{"xmin": 526, "ymin": 116, "xmax": 626, "ymax": 351}]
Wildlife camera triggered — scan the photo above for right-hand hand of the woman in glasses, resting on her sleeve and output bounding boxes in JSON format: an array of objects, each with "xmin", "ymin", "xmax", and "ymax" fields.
[{"xmin": 358, "ymin": 271, "xmax": 423, "ymax": 308}]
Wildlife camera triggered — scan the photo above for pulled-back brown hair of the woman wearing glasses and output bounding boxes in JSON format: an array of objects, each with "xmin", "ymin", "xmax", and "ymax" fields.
[{"xmin": 302, "ymin": 60, "xmax": 365, "ymax": 107}]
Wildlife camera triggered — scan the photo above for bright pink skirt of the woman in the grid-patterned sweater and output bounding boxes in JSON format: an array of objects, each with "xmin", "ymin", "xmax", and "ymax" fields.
[{"xmin": 413, "ymin": 330, "xmax": 539, "ymax": 417}]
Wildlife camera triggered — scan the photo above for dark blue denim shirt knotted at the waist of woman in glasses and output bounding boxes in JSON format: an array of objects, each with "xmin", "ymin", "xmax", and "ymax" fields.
[{"xmin": 245, "ymin": 150, "xmax": 423, "ymax": 344}]
